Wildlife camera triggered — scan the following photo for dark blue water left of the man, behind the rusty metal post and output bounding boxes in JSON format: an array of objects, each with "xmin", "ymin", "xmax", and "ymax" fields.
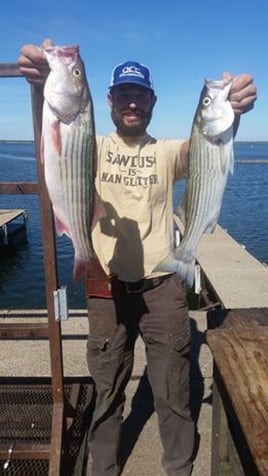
[{"xmin": 0, "ymin": 143, "xmax": 85, "ymax": 309}]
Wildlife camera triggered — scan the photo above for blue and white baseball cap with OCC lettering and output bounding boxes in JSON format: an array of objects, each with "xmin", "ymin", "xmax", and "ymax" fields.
[{"xmin": 109, "ymin": 61, "xmax": 154, "ymax": 92}]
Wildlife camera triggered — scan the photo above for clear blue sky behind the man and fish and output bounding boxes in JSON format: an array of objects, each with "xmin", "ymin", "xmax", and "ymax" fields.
[{"xmin": 0, "ymin": 0, "xmax": 268, "ymax": 141}]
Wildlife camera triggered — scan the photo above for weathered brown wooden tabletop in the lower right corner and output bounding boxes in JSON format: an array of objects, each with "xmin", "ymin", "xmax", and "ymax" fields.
[{"xmin": 206, "ymin": 326, "xmax": 268, "ymax": 476}]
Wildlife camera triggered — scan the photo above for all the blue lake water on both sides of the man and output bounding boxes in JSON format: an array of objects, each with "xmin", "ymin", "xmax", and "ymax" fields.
[{"xmin": 0, "ymin": 142, "xmax": 268, "ymax": 309}]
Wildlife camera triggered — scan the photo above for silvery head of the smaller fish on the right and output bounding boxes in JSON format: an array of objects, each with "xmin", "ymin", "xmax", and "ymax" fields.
[{"xmin": 195, "ymin": 79, "xmax": 234, "ymax": 141}]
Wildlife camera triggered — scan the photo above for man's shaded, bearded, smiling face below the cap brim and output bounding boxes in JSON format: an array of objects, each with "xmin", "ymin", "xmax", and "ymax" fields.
[{"xmin": 108, "ymin": 84, "xmax": 156, "ymax": 137}]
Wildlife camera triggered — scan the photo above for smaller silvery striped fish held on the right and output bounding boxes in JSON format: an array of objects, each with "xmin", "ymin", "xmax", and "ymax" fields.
[{"xmin": 155, "ymin": 78, "xmax": 235, "ymax": 287}]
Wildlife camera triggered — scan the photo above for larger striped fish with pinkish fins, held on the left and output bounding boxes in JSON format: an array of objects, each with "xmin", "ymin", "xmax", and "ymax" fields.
[{"xmin": 41, "ymin": 45, "xmax": 105, "ymax": 283}]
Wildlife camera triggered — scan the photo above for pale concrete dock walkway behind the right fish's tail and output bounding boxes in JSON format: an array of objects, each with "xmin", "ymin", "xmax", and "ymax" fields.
[{"xmin": 197, "ymin": 226, "xmax": 268, "ymax": 309}]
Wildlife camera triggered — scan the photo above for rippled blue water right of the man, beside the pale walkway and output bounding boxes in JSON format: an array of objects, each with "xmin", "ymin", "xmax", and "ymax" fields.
[{"xmin": 174, "ymin": 142, "xmax": 268, "ymax": 264}]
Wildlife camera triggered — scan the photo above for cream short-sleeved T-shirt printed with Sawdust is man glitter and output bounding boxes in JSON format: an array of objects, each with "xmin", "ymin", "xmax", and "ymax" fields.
[{"xmin": 92, "ymin": 133, "xmax": 185, "ymax": 282}]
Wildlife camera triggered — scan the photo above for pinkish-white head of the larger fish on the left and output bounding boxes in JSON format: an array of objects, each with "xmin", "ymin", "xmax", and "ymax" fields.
[{"xmin": 44, "ymin": 45, "xmax": 89, "ymax": 124}]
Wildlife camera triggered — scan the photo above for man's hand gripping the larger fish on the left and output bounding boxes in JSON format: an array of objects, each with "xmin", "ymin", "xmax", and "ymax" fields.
[{"xmin": 18, "ymin": 39, "xmax": 53, "ymax": 85}]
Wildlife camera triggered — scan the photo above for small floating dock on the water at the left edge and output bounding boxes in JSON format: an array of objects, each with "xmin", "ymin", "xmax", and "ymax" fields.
[{"xmin": 0, "ymin": 209, "xmax": 28, "ymax": 246}]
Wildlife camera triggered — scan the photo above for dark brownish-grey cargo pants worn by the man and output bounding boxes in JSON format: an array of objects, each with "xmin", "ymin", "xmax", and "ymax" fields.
[{"xmin": 88, "ymin": 275, "xmax": 195, "ymax": 476}]
